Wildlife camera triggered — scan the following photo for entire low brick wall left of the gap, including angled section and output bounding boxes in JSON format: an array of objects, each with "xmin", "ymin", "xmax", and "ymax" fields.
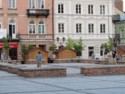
[{"xmin": 0, "ymin": 63, "xmax": 66, "ymax": 77}]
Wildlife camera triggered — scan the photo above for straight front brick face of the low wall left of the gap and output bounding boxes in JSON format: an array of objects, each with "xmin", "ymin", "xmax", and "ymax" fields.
[{"xmin": 18, "ymin": 68, "xmax": 66, "ymax": 77}]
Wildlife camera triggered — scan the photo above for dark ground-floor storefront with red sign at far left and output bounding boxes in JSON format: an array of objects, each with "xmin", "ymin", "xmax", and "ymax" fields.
[{"xmin": 0, "ymin": 42, "xmax": 18, "ymax": 60}]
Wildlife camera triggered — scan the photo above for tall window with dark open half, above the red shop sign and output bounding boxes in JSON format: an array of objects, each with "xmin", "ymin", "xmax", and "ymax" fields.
[{"xmin": 9, "ymin": 20, "xmax": 16, "ymax": 38}]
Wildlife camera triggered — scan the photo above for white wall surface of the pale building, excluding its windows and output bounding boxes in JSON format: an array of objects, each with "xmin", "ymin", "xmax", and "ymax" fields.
[{"xmin": 54, "ymin": 0, "xmax": 114, "ymax": 58}]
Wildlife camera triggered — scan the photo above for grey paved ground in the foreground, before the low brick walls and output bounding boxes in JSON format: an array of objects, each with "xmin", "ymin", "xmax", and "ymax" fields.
[{"xmin": 0, "ymin": 71, "xmax": 125, "ymax": 94}]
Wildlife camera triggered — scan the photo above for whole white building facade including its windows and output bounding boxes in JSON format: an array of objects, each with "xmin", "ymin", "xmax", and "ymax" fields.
[{"xmin": 54, "ymin": 0, "xmax": 114, "ymax": 59}]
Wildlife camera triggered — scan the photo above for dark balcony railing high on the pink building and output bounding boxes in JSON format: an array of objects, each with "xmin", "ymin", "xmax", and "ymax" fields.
[{"xmin": 27, "ymin": 9, "xmax": 49, "ymax": 17}]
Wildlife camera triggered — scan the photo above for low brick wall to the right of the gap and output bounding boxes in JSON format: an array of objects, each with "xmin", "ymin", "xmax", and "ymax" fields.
[{"xmin": 81, "ymin": 65, "xmax": 125, "ymax": 76}]
